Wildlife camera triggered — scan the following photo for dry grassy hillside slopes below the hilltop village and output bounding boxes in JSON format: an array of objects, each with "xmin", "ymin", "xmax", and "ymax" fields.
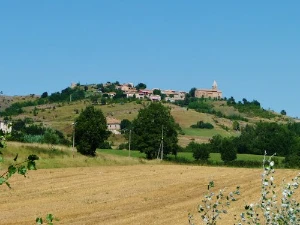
[{"xmin": 0, "ymin": 85, "xmax": 291, "ymax": 148}]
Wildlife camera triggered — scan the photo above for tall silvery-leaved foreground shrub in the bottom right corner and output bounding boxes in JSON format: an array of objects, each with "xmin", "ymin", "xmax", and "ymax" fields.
[{"xmin": 239, "ymin": 153, "xmax": 300, "ymax": 225}]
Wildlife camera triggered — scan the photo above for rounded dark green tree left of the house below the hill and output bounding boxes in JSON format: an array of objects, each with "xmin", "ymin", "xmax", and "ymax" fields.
[{"xmin": 75, "ymin": 106, "xmax": 109, "ymax": 156}]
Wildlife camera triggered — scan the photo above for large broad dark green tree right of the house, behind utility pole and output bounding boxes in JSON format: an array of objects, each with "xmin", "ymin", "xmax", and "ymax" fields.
[{"xmin": 131, "ymin": 103, "xmax": 178, "ymax": 159}]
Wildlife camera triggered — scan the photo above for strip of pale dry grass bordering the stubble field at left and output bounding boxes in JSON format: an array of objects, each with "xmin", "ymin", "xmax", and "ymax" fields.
[{"xmin": 0, "ymin": 142, "xmax": 156, "ymax": 170}]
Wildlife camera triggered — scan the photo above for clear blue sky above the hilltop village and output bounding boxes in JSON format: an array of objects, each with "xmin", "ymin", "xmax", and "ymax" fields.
[{"xmin": 0, "ymin": 0, "xmax": 300, "ymax": 117}]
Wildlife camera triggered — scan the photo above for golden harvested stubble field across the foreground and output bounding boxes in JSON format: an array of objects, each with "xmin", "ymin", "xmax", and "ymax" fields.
[{"xmin": 0, "ymin": 165, "xmax": 298, "ymax": 225}]
